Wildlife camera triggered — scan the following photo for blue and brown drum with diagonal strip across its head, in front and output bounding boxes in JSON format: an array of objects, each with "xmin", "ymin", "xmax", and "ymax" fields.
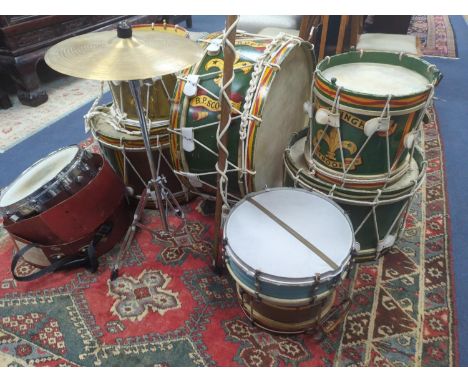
[{"xmin": 224, "ymin": 188, "xmax": 354, "ymax": 333}]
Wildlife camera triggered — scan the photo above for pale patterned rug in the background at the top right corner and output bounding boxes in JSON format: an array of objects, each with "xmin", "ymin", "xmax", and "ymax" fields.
[{"xmin": 408, "ymin": 16, "xmax": 457, "ymax": 58}]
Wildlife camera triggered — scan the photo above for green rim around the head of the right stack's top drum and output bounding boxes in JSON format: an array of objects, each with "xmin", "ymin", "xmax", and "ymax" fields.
[{"xmin": 314, "ymin": 51, "xmax": 441, "ymax": 100}]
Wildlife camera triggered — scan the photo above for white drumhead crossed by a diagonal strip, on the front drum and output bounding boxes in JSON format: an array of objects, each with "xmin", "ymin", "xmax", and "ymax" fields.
[{"xmin": 224, "ymin": 188, "xmax": 354, "ymax": 279}]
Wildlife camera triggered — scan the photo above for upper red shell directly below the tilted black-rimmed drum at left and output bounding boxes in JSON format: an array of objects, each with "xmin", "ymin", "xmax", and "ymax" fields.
[{"xmin": 4, "ymin": 154, "xmax": 125, "ymax": 245}]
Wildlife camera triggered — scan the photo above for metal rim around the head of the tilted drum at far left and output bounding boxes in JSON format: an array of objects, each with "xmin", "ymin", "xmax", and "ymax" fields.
[{"xmin": 0, "ymin": 144, "xmax": 86, "ymax": 214}]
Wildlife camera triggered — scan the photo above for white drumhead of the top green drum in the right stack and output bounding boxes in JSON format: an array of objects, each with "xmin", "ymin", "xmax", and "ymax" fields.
[{"xmin": 322, "ymin": 62, "xmax": 429, "ymax": 96}]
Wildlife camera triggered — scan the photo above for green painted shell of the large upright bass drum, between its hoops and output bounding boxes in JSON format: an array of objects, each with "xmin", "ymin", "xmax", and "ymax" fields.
[{"xmin": 171, "ymin": 33, "xmax": 271, "ymax": 194}]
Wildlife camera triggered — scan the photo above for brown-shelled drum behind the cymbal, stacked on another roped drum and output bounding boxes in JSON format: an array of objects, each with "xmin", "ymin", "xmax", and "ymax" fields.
[{"xmin": 109, "ymin": 24, "xmax": 189, "ymax": 133}]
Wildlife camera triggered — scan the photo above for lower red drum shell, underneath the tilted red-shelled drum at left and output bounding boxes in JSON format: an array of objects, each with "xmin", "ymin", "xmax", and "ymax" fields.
[{"xmin": 10, "ymin": 196, "xmax": 133, "ymax": 268}]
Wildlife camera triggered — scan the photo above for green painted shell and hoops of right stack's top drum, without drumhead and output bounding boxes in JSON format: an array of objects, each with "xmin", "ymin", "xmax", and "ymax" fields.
[{"xmin": 309, "ymin": 52, "xmax": 442, "ymax": 180}]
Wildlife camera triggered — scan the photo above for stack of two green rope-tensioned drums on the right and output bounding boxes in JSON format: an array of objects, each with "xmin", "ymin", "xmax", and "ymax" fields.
[{"xmin": 284, "ymin": 51, "xmax": 441, "ymax": 261}]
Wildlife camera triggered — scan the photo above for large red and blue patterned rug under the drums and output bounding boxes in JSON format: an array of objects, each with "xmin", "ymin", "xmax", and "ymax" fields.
[{"xmin": 0, "ymin": 109, "xmax": 458, "ymax": 366}]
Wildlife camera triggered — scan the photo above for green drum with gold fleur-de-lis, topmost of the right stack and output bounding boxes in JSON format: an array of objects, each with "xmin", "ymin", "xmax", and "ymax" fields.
[{"xmin": 305, "ymin": 51, "xmax": 442, "ymax": 189}]
